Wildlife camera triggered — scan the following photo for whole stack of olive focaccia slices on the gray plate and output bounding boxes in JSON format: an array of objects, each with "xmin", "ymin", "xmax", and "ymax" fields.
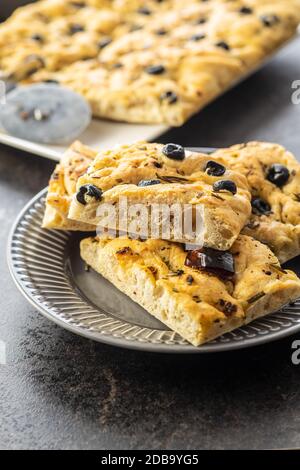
[{"xmin": 44, "ymin": 142, "xmax": 300, "ymax": 346}]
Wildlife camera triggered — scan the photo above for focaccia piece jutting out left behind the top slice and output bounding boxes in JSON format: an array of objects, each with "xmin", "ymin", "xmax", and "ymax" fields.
[{"xmin": 43, "ymin": 142, "xmax": 97, "ymax": 231}]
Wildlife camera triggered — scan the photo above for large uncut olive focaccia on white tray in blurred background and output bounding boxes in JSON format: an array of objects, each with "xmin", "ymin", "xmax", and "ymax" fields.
[{"xmin": 0, "ymin": 0, "xmax": 300, "ymax": 126}]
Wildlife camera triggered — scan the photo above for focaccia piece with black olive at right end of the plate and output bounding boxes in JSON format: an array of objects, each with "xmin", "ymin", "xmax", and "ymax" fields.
[{"xmin": 212, "ymin": 142, "xmax": 300, "ymax": 263}]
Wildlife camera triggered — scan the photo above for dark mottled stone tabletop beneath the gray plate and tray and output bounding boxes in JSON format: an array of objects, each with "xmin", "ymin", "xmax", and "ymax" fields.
[{"xmin": 0, "ymin": 30, "xmax": 300, "ymax": 449}]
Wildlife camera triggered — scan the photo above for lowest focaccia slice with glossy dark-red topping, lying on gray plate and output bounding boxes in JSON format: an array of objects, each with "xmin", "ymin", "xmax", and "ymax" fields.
[{"xmin": 81, "ymin": 235, "xmax": 300, "ymax": 346}]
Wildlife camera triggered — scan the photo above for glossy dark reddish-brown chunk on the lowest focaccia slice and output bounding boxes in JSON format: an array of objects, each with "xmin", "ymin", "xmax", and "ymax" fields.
[{"xmin": 185, "ymin": 247, "xmax": 235, "ymax": 278}]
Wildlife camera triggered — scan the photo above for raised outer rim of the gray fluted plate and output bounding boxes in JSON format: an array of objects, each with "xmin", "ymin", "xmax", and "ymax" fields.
[{"xmin": 6, "ymin": 151, "xmax": 300, "ymax": 354}]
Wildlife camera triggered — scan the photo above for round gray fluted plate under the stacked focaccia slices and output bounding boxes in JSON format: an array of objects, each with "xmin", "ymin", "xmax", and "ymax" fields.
[{"xmin": 8, "ymin": 149, "xmax": 300, "ymax": 353}]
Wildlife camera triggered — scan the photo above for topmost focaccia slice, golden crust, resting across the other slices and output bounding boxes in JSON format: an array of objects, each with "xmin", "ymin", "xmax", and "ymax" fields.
[{"xmin": 69, "ymin": 142, "xmax": 251, "ymax": 250}]
